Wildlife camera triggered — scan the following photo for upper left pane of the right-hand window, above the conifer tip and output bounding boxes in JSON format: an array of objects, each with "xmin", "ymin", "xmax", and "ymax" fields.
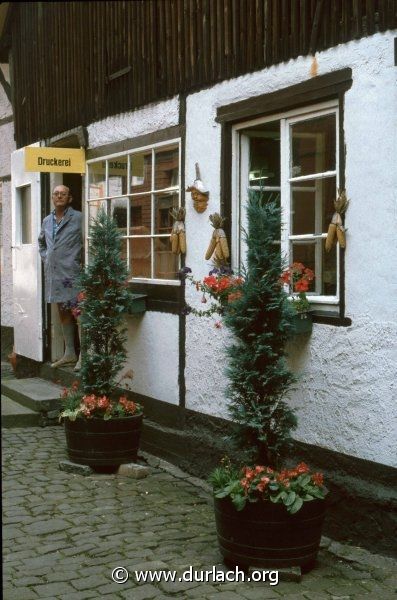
[{"xmin": 243, "ymin": 121, "xmax": 280, "ymax": 187}]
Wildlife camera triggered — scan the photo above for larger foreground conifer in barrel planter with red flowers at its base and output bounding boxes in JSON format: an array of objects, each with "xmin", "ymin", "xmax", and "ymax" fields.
[{"xmin": 190, "ymin": 192, "xmax": 326, "ymax": 569}]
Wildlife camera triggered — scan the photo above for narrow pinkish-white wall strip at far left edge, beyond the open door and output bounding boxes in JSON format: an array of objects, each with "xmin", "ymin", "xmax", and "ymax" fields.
[{"xmin": 0, "ymin": 64, "xmax": 15, "ymax": 327}]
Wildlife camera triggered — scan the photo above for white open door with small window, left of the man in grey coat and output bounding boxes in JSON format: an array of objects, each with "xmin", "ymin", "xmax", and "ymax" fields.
[{"xmin": 11, "ymin": 144, "xmax": 43, "ymax": 362}]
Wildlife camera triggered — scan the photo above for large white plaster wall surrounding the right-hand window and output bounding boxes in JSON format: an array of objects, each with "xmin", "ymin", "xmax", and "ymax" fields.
[{"xmin": 185, "ymin": 32, "xmax": 397, "ymax": 465}]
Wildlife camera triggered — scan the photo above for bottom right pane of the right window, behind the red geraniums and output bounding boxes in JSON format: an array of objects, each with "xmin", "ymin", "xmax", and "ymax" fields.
[{"xmin": 291, "ymin": 239, "xmax": 336, "ymax": 296}]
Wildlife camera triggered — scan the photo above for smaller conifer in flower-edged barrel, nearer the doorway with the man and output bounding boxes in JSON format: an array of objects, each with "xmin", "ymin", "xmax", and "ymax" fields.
[{"xmin": 60, "ymin": 211, "xmax": 143, "ymax": 470}]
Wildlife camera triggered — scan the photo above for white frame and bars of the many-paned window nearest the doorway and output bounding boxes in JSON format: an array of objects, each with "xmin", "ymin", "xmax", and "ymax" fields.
[{"xmin": 85, "ymin": 138, "xmax": 181, "ymax": 286}]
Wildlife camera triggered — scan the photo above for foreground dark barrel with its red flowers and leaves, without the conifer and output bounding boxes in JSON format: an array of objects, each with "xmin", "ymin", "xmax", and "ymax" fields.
[{"xmin": 209, "ymin": 459, "xmax": 327, "ymax": 570}]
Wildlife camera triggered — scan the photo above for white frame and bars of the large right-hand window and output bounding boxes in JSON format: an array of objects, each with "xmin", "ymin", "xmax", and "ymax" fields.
[{"xmin": 232, "ymin": 100, "xmax": 340, "ymax": 310}]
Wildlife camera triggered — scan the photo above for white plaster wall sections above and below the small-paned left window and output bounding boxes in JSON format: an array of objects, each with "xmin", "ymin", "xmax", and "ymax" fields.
[{"xmin": 88, "ymin": 98, "xmax": 179, "ymax": 404}]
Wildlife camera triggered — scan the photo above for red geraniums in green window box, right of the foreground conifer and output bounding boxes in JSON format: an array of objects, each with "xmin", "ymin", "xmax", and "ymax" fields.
[{"xmin": 280, "ymin": 262, "xmax": 314, "ymax": 333}]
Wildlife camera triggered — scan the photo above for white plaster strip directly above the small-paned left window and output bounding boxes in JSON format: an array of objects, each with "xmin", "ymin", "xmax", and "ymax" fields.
[{"xmin": 87, "ymin": 97, "xmax": 179, "ymax": 148}]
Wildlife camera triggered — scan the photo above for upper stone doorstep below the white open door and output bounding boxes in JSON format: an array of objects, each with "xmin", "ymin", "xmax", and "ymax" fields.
[{"xmin": 1, "ymin": 377, "xmax": 63, "ymax": 414}]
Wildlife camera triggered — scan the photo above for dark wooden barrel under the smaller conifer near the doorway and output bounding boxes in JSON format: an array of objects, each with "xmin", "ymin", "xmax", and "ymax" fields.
[{"xmin": 65, "ymin": 415, "xmax": 143, "ymax": 470}]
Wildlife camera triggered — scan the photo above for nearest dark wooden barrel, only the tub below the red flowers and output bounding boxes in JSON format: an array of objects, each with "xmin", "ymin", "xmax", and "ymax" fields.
[{"xmin": 214, "ymin": 498, "xmax": 325, "ymax": 571}]
